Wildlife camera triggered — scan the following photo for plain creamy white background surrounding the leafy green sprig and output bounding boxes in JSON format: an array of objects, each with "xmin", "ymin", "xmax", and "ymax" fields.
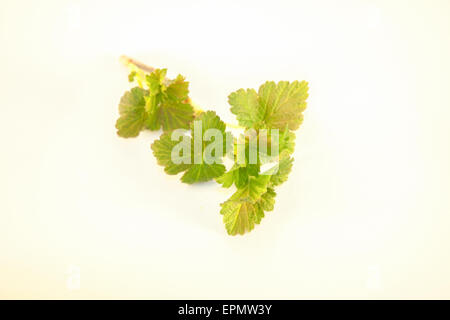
[{"xmin": 0, "ymin": 0, "xmax": 450, "ymax": 299}]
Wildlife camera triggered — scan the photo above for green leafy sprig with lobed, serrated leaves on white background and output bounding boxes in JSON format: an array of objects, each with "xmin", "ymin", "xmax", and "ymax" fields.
[{"xmin": 116, "ymin": 57, "xmax": 308, "ymax": 235}]
